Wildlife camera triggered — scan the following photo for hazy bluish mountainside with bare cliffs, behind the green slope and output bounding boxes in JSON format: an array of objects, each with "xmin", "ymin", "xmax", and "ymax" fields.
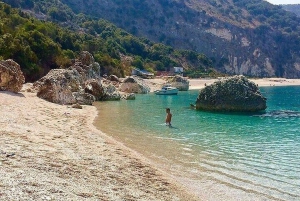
[{"xmin": 62, "ymin": 0, "xmax": 300, "ymax": 78}]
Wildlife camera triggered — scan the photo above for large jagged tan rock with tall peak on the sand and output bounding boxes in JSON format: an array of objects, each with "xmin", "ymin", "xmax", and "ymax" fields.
[{"xmin": 34, "ymin": 52, "xmax": 102, "ymax": 105}]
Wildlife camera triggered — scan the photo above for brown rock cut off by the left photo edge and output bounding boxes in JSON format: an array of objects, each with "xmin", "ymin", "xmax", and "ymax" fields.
[{"xmin": 0, "ymin": 59, "xmax": 25, "ymax": 93}]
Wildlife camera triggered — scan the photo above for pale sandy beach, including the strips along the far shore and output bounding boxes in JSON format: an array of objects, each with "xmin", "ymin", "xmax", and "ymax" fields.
[{"xmin": 0, "ymin": 78, "xmax": 300, "ymax": 200}]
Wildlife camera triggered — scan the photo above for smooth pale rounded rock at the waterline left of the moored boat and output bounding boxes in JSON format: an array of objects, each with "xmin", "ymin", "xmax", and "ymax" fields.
[{"xmin": 119, "ymin": 77, "xmax": 150, "ymax": 94}]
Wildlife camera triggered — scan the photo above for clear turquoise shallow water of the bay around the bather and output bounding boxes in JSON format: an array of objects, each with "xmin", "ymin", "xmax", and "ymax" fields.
[{"xmin": 95, "ymin": 87, "xmax": 300, "ymax": 201}]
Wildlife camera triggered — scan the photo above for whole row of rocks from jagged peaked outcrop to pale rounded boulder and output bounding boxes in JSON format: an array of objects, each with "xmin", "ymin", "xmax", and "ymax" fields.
[{"xmin": 33, "ymin": 52, "xmax": 150, "ymax": 105}]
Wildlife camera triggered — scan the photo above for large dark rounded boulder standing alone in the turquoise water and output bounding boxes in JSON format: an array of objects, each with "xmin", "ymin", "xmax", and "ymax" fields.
[{"xmin": 196, "ymin": 76, "xmax": 267, "ymax": 112}]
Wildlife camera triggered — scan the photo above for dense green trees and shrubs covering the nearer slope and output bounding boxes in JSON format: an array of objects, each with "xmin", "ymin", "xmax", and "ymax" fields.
[{"xmin": 0, "ymin": 0, "xmax": 215, "ymax": 81}]
